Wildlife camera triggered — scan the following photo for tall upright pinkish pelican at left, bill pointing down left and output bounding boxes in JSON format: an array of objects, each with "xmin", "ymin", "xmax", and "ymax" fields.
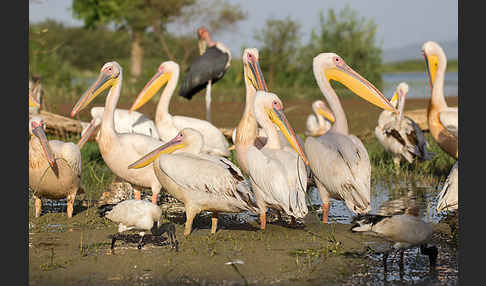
[{"xmin": 71, "ymin": 62, "xmax": 163, "ymax": 204}]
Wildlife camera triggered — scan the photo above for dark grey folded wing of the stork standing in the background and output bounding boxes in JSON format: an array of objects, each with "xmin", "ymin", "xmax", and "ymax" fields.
[{"xmin": 179, "ymin": 46, "xmax": 229, "ymax": 99}]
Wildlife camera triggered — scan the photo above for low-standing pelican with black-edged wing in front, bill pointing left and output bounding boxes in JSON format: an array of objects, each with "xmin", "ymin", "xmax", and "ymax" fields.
[{"xmin": 128, "ymin": 128, "xmax": 258, "ymax": 237}]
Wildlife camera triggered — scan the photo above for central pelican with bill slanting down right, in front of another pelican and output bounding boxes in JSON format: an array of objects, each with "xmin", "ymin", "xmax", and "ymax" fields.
[{"xmin": 245, "ymin": 90, "xmax": 308, "ymax": 229}]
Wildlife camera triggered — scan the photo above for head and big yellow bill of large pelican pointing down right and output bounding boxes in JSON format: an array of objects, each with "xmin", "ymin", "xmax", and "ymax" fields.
[{"xmin": 313, "ymin": 53, "xmax": 398, "ymax": 113}]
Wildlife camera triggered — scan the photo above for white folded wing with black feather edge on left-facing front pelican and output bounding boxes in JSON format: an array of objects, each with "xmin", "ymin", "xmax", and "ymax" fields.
[{"xmin": 158, "ymin": 153, "xmax": 252, "ymax": 210}]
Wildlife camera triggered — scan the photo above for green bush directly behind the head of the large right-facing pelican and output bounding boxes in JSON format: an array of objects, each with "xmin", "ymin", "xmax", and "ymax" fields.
[{"xmin": 300, "ymin": 5, "xmax": 383, "ymax": 89}]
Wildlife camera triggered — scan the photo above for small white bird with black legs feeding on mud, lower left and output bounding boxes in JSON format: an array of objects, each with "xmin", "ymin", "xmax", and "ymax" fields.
[{"xmin": 98, "ymin": 200, "xmax": 177, "ymax": 250}]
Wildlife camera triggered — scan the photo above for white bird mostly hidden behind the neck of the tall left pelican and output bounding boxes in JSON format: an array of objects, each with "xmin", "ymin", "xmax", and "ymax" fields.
[{"xmin": 78, "ymin": 106, "xmax": 159, "ymax": 148}]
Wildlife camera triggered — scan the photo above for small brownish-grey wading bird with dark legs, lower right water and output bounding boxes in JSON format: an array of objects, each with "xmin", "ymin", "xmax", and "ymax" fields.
[{"xmin": 351, "ymin": 197, "xmax": 439, "ymax": 272}]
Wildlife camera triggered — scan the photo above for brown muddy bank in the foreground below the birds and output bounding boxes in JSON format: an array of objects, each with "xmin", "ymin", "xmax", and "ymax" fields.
[{"xmin": 29, "ymin": 204, "xmax": 457, "ymax": 285}]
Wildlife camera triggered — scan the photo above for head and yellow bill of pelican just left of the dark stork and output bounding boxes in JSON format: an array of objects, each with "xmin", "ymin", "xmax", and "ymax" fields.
[{"xmin": 130, "ymin": 61, "xmax": 179, "ymax": 111}]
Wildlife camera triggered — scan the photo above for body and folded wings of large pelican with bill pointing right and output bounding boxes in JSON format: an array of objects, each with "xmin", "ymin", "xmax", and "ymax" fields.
[{"xmin": 305, "ymin": 131, "xmax": 371, "ymax": 213}]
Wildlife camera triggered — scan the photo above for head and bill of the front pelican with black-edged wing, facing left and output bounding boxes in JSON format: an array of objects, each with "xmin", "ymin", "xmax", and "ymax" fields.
[{"xmin": 128, "ymin": 128, "xmax": 204, "ymax": 169}]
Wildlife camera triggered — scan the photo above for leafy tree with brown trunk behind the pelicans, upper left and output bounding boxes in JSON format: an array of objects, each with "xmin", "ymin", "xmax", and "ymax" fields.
[{"xmin": 72, "ymin": 0, "xmax": 247, "ymax": 79}]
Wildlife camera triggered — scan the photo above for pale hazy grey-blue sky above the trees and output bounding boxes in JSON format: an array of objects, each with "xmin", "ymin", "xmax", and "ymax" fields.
[{"xmin": 29, "ymin": 0, "xmax": 458, "ymax": 55}]
